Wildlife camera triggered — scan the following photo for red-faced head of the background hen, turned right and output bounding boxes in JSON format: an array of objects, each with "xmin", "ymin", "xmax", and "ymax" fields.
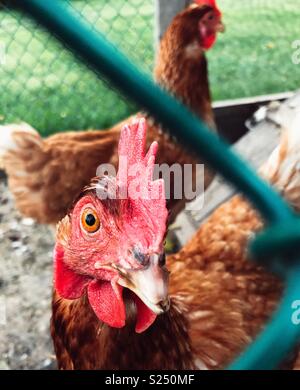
[{"xmin": 170, "ymin": 0, "xmax": 225, "ymax": 50}]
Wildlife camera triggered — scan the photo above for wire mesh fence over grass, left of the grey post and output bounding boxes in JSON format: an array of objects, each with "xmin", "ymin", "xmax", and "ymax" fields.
[{"xmin": 0, "ymin": 0, "xmax": 153, "ymax": 135}]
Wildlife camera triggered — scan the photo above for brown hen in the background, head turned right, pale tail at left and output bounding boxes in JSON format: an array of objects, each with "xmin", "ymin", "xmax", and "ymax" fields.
[{"xmin": 0, "ymin": 0, "xmax": 223, "ymax": 223}]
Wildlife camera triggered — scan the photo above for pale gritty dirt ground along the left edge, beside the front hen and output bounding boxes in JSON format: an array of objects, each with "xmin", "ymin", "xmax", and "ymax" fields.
[{"xmin": 0, "ymin": 179, "xmax": 56, "ymax": 369}]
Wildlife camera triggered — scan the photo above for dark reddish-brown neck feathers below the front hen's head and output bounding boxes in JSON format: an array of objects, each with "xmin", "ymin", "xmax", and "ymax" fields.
[{"xmin": 51, "ymin": 295, "xmax": 194, "ymax": 369}]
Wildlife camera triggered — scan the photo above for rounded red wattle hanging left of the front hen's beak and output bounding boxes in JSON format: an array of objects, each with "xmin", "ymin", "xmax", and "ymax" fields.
[{"xmin": 88, "ymin": 280, "xmax": 126, "ymax": 328}]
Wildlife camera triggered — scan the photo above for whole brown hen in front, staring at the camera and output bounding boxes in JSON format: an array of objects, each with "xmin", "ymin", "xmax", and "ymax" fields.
[{"xmin": 52, "ymin": 117, "xmax": 300, "ymax": 369}]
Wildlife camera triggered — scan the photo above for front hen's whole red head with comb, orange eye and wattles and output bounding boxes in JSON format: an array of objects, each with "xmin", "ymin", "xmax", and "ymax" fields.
[{"xmin": 54, "ymin": 119, "xmax": 169, "ymax": 333}]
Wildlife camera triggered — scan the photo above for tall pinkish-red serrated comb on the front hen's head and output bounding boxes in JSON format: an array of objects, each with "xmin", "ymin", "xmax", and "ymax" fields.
[{"xmin": 117, "ymin": 118, "xmax": 168, "ymax": 250}]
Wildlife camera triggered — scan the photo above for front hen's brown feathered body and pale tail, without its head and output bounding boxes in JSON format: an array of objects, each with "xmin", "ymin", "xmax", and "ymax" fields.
[{"xmin": 52, "ymin": 114, "xmax": 300, "ymax": 369}]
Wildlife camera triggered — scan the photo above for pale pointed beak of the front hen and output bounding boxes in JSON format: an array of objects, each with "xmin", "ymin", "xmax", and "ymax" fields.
[{"xmin": 118, "ymin": 254, "xmax": 170, "ymax": 314}]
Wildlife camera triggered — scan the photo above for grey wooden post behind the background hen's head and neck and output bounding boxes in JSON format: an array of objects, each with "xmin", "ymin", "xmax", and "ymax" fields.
[{"xmin": 155, "ymin": 0, "xmax": 193, "ymax": 45}]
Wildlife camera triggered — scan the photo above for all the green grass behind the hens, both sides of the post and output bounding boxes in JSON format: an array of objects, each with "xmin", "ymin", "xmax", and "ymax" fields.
[{"xmin": 0, "ymin": 0, "xmax": 300, "ymax": 135}]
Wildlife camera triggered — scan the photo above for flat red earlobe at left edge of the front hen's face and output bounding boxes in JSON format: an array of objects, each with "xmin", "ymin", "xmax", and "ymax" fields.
[{"xmin": 54, "ymin": 246, "xmax": 91, "ymax": 299}]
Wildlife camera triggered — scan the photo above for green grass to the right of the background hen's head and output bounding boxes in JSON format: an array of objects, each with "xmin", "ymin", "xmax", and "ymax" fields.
[{"xmin": 208, "ymin": 0, "xmax": 300, "ymax": 100}]
